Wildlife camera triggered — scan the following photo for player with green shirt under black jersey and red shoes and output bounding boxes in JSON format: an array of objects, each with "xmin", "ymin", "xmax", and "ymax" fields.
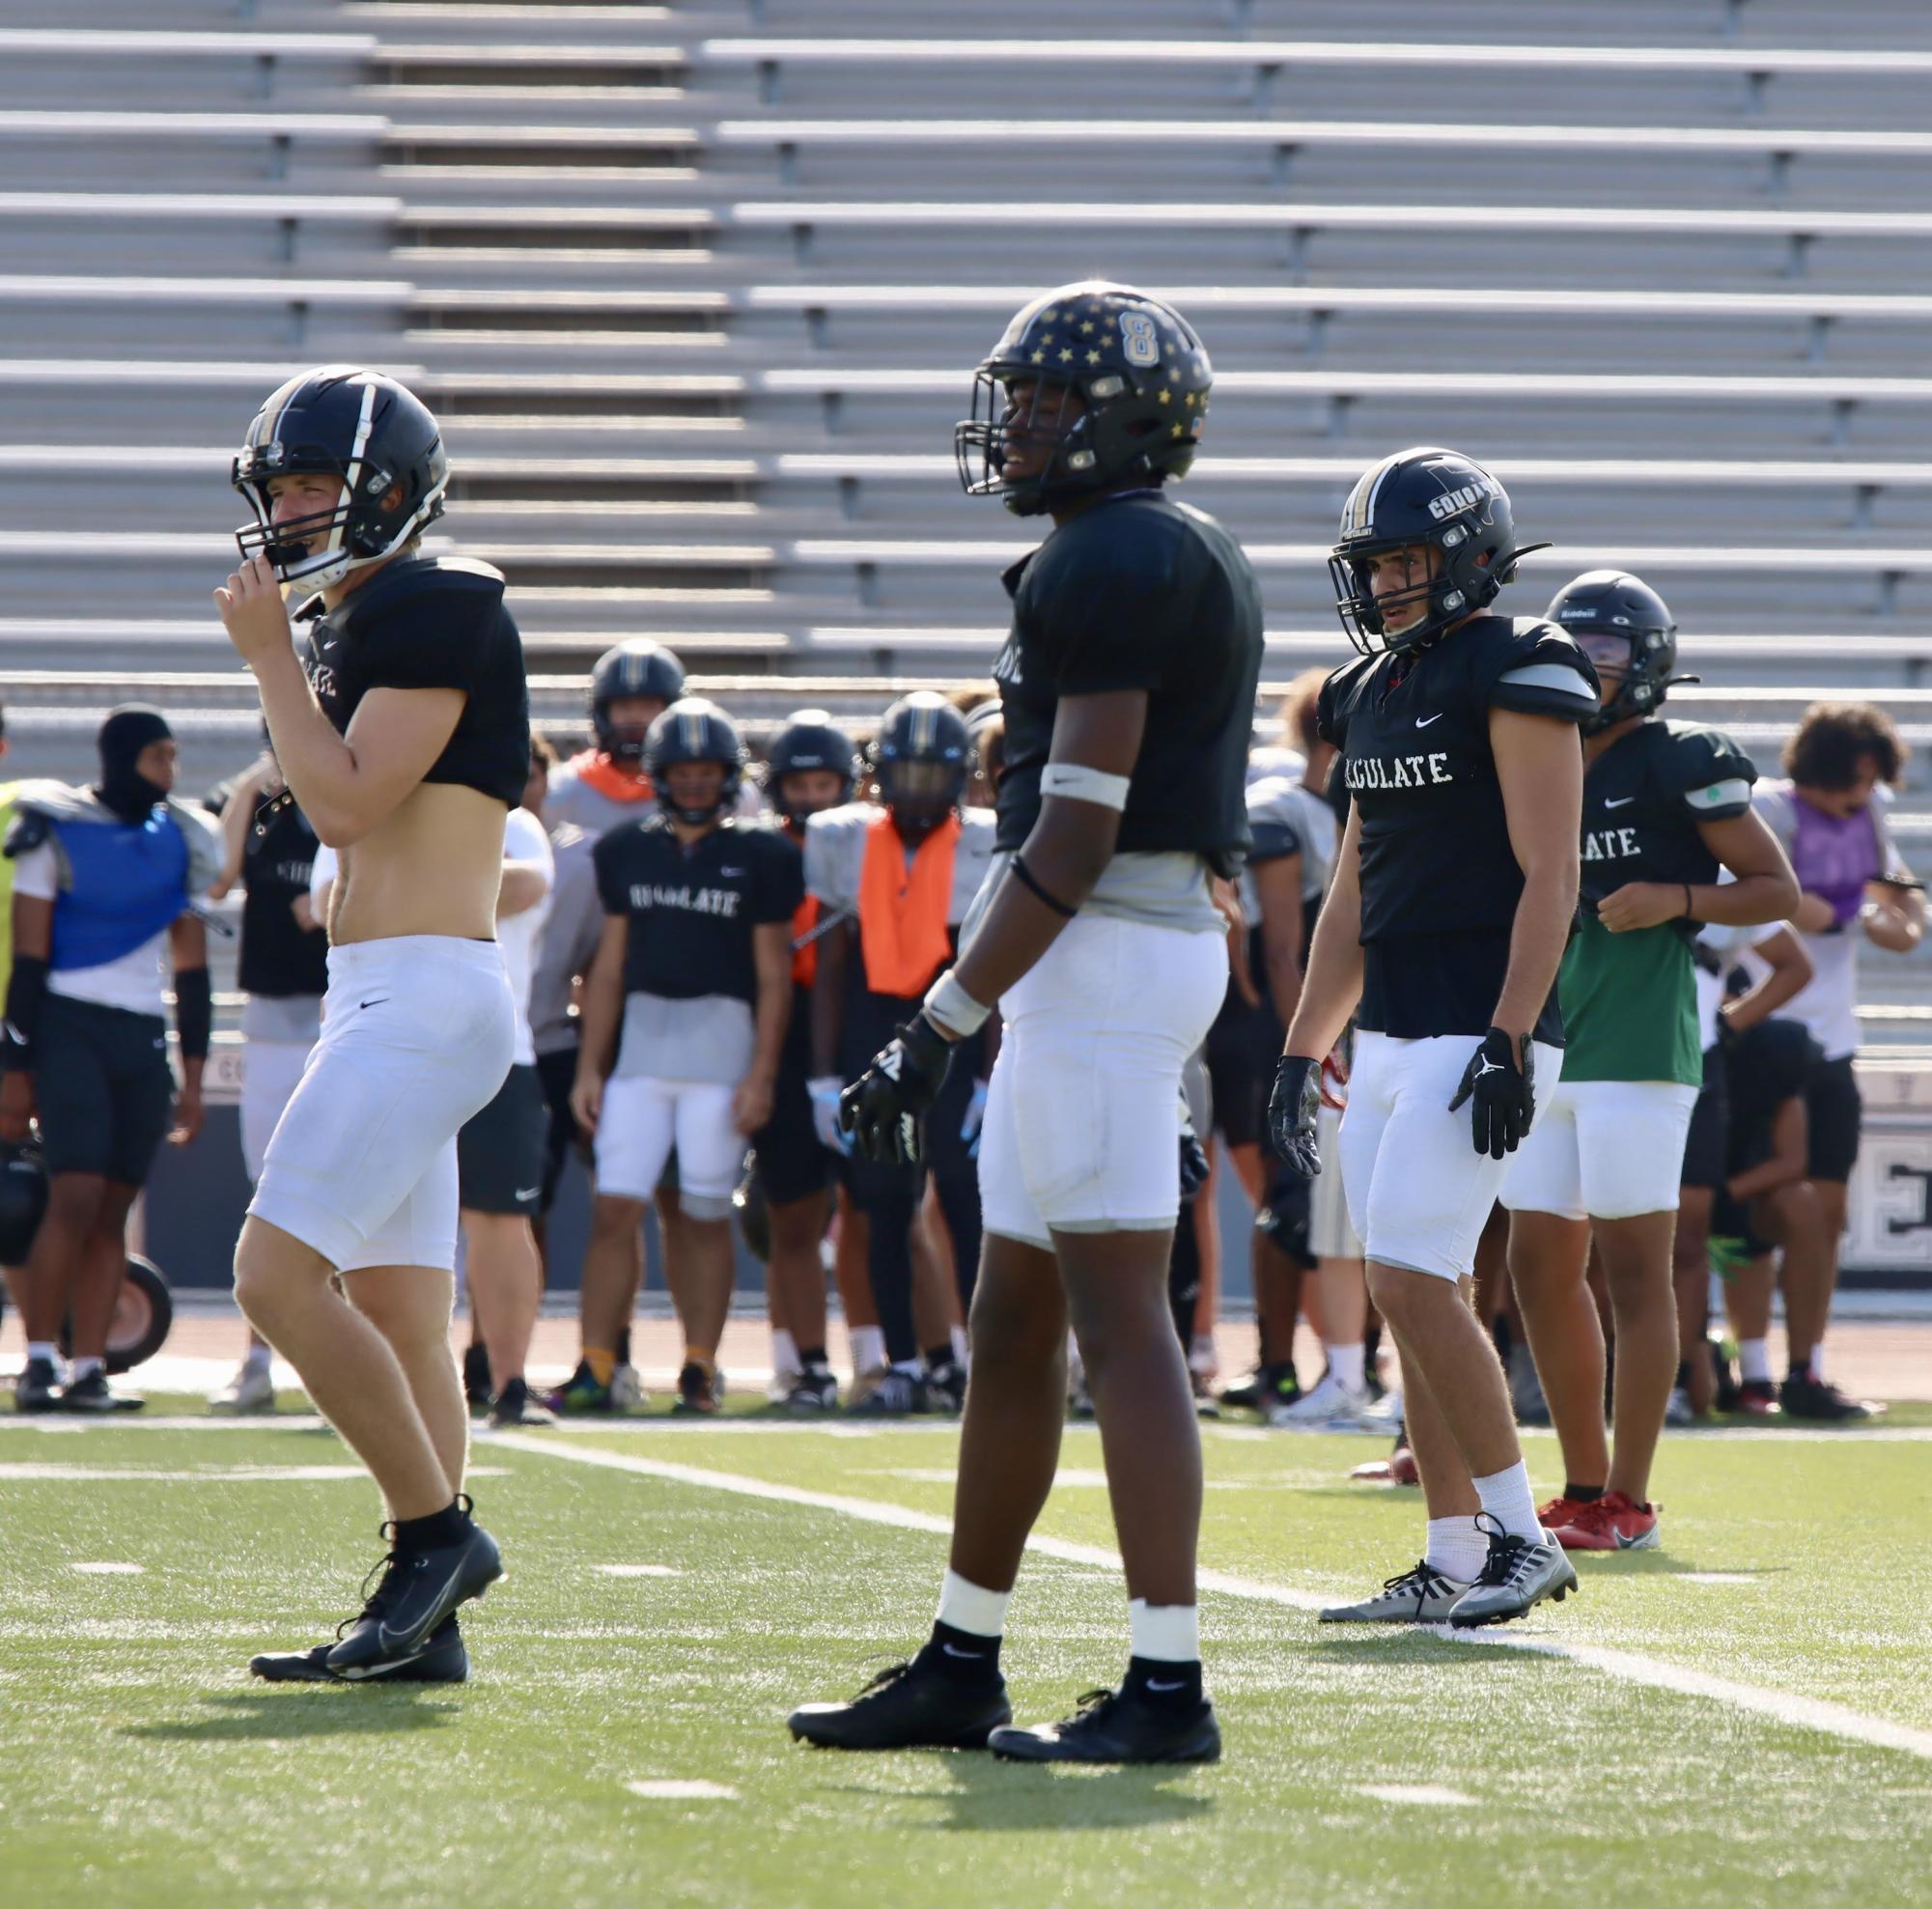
[{"xmin": 1503, "ymin": 570, "xmax": 1799, "ymax": 1552}]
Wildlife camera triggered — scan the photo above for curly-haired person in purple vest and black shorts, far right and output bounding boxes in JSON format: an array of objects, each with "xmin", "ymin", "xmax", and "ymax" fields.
[{"xmin": 1756, "ymin": 703, "xmax": 1926, "ymax": 1424}]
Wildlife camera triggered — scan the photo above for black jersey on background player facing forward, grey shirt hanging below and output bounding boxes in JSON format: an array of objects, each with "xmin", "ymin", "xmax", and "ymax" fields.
[{"xmin": 591, "ymin": 815, "xmax": 805, "ymax": 1007}]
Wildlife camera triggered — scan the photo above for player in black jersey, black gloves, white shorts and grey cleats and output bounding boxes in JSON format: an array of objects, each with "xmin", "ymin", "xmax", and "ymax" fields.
[{"xmin": 1270, "ymin": 448, "xmax": 1598, "ymax": 1627}]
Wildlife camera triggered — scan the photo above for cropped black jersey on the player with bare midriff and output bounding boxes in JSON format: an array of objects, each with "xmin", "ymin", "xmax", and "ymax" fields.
[{"xmin": 301, "ymin": 560, "xmax": 529, "ymax": 807}]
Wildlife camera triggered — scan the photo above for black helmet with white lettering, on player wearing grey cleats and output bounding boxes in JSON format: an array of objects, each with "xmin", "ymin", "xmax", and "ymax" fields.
[{"xmin": 1330, "ymin": 446, "xmax": 1544, "ymax": 655}]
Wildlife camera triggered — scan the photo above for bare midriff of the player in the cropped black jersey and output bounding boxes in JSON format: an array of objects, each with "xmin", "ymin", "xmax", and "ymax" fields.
[{"xmin": 328, "ymin": 782, "xmax": 508, "ymax": 944}]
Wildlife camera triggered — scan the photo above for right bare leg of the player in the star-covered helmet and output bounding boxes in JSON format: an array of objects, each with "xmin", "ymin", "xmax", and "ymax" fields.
[{"xmin": 1066, "ymin": 1231, "xmax": 1202, "ymax": 1606}]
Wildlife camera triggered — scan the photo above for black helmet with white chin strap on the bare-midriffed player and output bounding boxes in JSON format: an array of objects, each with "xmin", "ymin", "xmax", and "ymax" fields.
[{"xmin": 228, "ymin": 365, "xmax": 450, "ymax": 591}]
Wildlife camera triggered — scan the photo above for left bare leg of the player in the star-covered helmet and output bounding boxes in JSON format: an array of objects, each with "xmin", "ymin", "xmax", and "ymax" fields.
[{"xmin": 948, "ymin": 1233, "xmax": 1074, "ymax": 1592}]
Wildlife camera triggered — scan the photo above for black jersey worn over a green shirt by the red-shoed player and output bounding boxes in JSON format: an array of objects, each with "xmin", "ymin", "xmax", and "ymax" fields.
[{"xmin": 1582, "ymin": 718, "xmax": 1758, "ymax": 940}]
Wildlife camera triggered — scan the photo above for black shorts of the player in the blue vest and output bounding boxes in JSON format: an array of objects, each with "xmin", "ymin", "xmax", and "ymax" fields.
[{"xmin": 33, "ymin": 994, "xmax": 174, "ymax": 1187}]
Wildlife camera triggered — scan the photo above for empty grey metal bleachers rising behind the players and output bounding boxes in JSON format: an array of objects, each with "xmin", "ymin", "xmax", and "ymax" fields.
[{"xmin": 0, "ymin": 0, "xmax": 1932, "ymax": 1040}]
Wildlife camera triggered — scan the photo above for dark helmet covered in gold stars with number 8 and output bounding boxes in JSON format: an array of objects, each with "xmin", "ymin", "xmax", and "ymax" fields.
[{"xmin": 952, "ymin": 280, "xmax": 1214, "ymax": 518}]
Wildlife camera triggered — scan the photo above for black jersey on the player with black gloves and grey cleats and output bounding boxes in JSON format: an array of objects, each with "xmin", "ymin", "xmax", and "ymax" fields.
[{"xmin": 1318, "ymin": 616, "xmax": 1598, "ymax": 1046}]
